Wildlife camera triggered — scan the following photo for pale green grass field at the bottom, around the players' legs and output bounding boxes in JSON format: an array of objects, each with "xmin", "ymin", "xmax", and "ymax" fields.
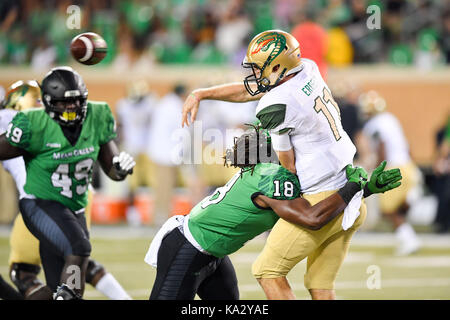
[{"xmin": 0, "ymin": 227, "xmax": 450, "ymax": 300}]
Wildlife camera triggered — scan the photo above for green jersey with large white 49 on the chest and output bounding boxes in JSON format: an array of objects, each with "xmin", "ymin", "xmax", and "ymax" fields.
[{"xmin": 6, "ymin": 101, "xmax": 117, "ymax": 211}]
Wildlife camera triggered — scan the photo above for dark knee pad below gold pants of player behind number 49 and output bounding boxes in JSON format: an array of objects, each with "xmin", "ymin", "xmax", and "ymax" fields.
[{"xmin": 9, "ymin": 263, "xmax": 44, "ymax": 296}]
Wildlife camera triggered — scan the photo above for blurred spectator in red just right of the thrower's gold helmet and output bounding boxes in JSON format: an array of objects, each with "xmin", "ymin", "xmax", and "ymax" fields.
[{"xmin": 291, "ymin": 9, "xmax": 328, "ymax": 80}]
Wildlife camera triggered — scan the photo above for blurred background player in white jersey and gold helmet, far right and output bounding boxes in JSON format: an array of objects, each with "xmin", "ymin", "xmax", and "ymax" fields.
[{"xmin": 359, "ymin": 90, "xmax": 420, "ymax": 255}]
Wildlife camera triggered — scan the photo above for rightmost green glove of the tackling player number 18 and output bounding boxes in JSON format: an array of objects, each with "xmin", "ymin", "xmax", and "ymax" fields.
[{"xmin": 364, "ymin": 161, "xmax": 402, "ymax": 197}]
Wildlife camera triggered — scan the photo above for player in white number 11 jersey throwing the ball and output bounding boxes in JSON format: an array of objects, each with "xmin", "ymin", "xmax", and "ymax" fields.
[{"xmin": 182, "ymin": 30, "xmax": 366, "ymax": 299}]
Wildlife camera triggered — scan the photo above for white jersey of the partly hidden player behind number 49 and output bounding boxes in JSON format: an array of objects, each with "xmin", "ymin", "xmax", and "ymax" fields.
[{"xmin": 0, "ymin": 109, "xmax": 27, "ymax": 199}]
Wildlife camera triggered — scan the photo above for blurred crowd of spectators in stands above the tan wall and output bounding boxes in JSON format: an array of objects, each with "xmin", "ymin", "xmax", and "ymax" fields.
[{"xmin": 0, "ymin": 0, "xmax": 450, "ymax": 69}]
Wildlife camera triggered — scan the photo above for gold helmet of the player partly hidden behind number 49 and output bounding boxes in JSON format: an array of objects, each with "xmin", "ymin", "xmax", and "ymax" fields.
[{"xmin": 2, "ymin": 80, "xmax": 41, "ymax": 111}]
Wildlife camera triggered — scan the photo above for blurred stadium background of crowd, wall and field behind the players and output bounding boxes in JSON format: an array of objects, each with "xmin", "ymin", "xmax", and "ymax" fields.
[{"xmin": 0, "ymin": 0, "xmax": 450, "ymax": 299}]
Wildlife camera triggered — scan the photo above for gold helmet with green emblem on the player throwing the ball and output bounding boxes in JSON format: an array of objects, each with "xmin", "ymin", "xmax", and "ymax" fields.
[{"xmin": 242, "ymin": 30, "xmax": 302, "ymax": 96}]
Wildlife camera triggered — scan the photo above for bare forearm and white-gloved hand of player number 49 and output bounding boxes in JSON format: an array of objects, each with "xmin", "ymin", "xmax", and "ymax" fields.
[{"xmin": 98, "ymin": 140, "xmax": 136, "ymax": 181}]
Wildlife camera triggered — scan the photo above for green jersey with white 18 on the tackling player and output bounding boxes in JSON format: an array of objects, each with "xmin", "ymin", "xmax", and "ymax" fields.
[{"xmin": 188, "ymin": 163, "xmax": 300, "ymax": 258}]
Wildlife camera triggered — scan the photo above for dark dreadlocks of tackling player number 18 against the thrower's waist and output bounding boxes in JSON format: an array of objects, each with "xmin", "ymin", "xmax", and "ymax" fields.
[{"xmin": 223, "ymin": 124, "xmax": 279, "ymax": 177}]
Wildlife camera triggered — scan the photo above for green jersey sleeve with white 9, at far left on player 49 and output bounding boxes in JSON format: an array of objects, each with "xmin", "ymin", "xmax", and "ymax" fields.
[{"xmin": 6, "ymin": 112, "xmax": 32, "ymax": 151}]
